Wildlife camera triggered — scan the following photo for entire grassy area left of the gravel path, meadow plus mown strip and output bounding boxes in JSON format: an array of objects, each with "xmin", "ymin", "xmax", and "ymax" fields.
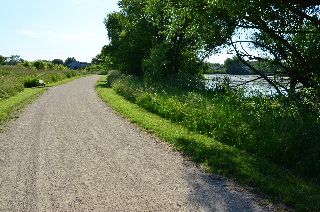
[{"xmin": 0, "ymin": 66, "xmax": 90, "ymax": 131}]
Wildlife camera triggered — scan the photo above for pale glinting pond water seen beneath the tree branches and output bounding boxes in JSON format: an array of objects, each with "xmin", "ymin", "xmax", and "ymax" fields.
[{"xmin": 205, "ymin": 74, "xmax": 288, "ymax": 96}]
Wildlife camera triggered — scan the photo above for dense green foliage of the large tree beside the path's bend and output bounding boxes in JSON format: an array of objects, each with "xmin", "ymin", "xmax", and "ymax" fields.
[{"xmin": 101, "ymin": 0, "xmax": 228, "ymax": 78}]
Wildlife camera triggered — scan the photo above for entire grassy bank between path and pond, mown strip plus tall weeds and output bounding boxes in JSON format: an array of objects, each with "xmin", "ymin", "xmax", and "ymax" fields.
[{"xmin": 97, "ymin": 73, "xmax": 320, "ymax": 211}]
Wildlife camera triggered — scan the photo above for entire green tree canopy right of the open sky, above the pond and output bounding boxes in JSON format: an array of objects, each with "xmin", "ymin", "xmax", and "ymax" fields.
[{"xmin": 101, "ymin": 0, "xmax": 320, "ymax": 93}]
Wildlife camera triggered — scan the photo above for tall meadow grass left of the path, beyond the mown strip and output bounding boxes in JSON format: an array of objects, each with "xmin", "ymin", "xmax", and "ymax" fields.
[{"xmin": 0, "ymin": 66, "xmax": 87, "ymax": 99}]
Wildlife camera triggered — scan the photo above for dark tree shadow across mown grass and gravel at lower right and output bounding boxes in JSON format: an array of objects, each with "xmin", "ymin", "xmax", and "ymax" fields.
[{"xmin": 175, "ymin": 136, "xmax": 319, "ymax": 211}]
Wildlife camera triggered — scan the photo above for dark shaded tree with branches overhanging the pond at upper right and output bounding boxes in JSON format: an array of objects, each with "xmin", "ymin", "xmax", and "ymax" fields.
[{"xmin": 168, "ymin": 0, "xmax": 320, "ymax": 93}]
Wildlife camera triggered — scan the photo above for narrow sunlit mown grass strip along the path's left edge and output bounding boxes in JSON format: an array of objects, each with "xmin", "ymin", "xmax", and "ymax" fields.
[{"xmin": 0, "ymin": 76, "xmax": 89, "ymax": 132}]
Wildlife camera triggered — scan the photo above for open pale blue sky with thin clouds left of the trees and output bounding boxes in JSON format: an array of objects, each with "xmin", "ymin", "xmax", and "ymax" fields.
[{"xmin": 0, "ymin": 0, "xmax": 119, "ymax": 62}]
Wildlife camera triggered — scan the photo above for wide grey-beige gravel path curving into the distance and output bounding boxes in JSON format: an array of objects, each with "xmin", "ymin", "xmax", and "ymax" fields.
[{"xmin": 0, "ymin": 76, "xmax": 276, "ymax": 212}]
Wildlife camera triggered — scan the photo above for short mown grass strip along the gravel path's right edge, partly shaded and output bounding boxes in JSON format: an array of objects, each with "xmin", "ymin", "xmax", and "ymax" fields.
[{"xmin": 97, "ymin": 77, "xmax": 320, "ymax": 211}]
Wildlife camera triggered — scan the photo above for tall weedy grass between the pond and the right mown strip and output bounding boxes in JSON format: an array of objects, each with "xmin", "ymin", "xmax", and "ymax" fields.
[{"xmin": 113, "ymin": 73, "xmax": 320, "ymax": 184}]
